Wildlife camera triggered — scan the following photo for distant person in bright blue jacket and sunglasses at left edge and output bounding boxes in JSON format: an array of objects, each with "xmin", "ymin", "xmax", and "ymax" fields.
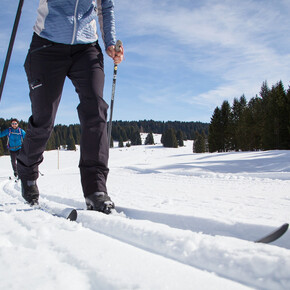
[{"xmin": 0, "ymin": 119, "xmax": 26, "ymax": 177}]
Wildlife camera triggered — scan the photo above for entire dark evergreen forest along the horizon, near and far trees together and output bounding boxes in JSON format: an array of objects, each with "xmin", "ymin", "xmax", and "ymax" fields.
[{"xmin": 0, "ymin": 81, "xmax": 290, "ymax": 155}]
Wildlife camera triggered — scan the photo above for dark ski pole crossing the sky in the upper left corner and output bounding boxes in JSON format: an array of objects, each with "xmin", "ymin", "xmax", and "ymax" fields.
[{"xmin": 0, "ymin": 0, "xmax": 24, "ymax": 101}]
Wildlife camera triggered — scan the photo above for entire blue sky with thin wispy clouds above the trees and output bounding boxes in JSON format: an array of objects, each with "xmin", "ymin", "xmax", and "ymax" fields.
[{"xmin": 0, "ymin": 0, "xmax": 290, "ymax": 124}]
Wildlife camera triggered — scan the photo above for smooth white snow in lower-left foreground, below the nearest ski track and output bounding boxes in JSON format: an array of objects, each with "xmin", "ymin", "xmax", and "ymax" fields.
[{"xmin": 0, "ymin": 179, "xmax": 247, "ymax": 289}]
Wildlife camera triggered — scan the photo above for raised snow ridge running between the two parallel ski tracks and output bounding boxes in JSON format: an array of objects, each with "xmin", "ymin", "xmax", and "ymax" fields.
[{"xmin": 4, "ymin": 178, "xmax": 290, "ymax": 289}]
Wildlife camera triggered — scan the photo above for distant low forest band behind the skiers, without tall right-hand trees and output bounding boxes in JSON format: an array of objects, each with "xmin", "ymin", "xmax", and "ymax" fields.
[{"xmin": 0, "ymin": 118, "xmax": 208, "ymax": 155}]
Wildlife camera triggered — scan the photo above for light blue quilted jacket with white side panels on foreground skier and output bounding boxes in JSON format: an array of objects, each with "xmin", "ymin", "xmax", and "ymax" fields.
[{"xmin": 33, "ymin": 0, "xmax": 116, "ymax": 49}]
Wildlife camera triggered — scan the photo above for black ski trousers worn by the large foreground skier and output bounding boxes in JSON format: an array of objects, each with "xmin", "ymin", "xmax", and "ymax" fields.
[{"xmin": 18, "ymin": 33, "xmax": 109, "ymax": 197}]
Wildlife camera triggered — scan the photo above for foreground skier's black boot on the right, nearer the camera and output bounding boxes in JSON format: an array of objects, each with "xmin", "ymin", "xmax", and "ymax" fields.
[{"xmin": 85, "ymin": 192, "xmax": 115, "ymax": 214}]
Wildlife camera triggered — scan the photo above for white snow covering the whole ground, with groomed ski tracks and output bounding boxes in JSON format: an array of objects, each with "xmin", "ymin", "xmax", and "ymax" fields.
[{"xmin": 0, "ymin": 135, "xmax": 290, "ymax": 290}]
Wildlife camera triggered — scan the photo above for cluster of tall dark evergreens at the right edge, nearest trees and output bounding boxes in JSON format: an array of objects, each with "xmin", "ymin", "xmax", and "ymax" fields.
[{"xmin": 208, "ymin": 81, "xmax": 290, "ymax": 152}]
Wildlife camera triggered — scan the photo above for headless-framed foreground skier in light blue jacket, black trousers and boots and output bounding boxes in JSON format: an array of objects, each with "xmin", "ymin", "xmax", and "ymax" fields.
[{"xmin": 18, "ymin": 0, "xmax": 123, "ymax": 214}]
